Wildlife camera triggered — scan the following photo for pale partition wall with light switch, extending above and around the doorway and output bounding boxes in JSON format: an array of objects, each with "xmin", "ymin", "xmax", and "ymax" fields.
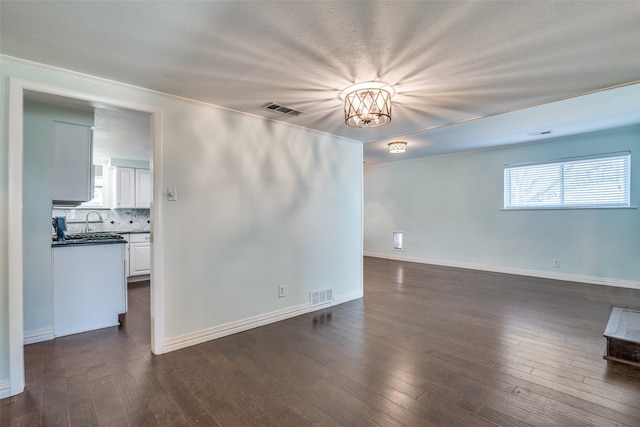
[{"xmin": 0, "ymin": 58, "xmax": 362, "ymax": 398}]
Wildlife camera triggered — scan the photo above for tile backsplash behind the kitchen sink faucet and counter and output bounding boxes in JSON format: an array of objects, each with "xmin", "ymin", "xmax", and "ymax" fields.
[{"xmin": 51, "ymin": 208, "xmax": 151, "ymax": 233}]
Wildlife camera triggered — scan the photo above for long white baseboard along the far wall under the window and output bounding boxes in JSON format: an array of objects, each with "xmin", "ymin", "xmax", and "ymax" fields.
[{"xmin": 364, "ymin": 252, "xmax": 640, "ymax": 289}]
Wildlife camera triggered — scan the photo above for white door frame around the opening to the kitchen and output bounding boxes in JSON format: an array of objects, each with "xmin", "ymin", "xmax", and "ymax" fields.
[{"xmin": 7, "ymin": 77, "xmax": 164, "ymax": 396}]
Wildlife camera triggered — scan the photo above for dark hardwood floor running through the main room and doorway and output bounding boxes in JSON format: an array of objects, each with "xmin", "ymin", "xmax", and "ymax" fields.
[{"xmin": 0, "ymin": 258, "xmax": 640, "ymax": 427}]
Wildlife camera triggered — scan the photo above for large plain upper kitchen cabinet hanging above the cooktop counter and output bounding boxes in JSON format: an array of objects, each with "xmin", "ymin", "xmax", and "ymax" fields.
[{"xmin": 52, "ymin": 121, "xmax": 93, "ymax": 206}]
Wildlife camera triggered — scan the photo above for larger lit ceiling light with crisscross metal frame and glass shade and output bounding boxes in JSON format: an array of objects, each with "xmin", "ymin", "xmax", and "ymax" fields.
[{"xmin": 340, "ymin": 82, "xmax": 393, "ymax": 128}]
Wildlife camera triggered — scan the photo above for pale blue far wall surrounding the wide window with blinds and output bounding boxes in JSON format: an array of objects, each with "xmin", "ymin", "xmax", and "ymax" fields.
[{"xmin": 364, "ymin": 127, "xmax": 640, "ymax": 287}]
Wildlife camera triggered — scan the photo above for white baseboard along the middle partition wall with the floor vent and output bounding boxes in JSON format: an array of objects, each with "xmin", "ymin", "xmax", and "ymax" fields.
[{"xmin": 163, "ymin": 289, "xmax": 363, "ymax": 353}]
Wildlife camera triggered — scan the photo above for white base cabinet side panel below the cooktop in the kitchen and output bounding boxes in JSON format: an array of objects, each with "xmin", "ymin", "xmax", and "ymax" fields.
[{"xmin": 52, "ymin": 243, "xmax": 127, "ymax": 337}]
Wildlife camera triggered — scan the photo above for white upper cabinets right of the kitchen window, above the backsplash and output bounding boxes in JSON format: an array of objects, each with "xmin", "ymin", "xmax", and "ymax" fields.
[{"xmin": 111, "ymin": 167, "xmax": 151, "ymax": 209}]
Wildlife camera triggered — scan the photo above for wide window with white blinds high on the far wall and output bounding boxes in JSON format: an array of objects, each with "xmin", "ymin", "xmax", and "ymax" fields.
[{"xmin": 504, "ymin": 152, "xmax": 631, "ymax": 209}]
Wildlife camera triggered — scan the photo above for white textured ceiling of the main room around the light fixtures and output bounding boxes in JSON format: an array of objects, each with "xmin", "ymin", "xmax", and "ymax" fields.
[{"xmin": 0, "ymin": 0, "xmax": 640, "ymax": 164}]
